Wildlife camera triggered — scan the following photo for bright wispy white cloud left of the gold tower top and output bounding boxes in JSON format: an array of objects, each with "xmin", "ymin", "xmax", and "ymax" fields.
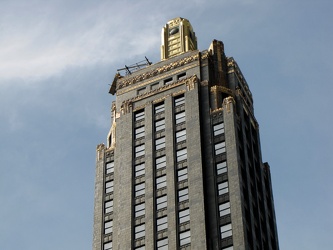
[{"xmin": 0, "ymin": 0, "xmax": 160, "ymax": 80}]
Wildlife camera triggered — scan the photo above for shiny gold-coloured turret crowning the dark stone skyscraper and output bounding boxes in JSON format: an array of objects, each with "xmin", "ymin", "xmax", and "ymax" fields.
[{"xmin": 161, "ymin": 17, "xmax": 197, "ymax": 60}]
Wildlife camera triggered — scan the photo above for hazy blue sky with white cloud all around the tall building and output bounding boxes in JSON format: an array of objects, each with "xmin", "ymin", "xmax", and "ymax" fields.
[{"xmin": 0, "ymin": 0, "xmax": 333, "ymax": 250}]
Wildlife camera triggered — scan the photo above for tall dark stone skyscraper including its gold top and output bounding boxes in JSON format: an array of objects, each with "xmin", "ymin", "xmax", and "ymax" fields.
[{"xmin": 93, "ymin": 18, "xmax": 279, "ymax": 250}]
